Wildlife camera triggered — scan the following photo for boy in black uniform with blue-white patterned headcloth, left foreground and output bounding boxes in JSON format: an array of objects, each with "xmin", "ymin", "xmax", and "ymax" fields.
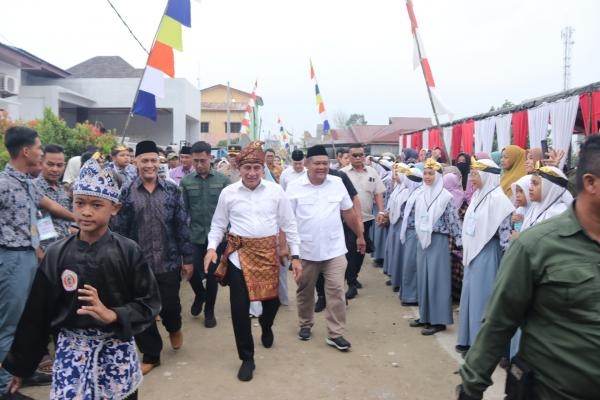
[{"xmin": 2, "ymin": 158, "xmax": 160, "ymax": 399}]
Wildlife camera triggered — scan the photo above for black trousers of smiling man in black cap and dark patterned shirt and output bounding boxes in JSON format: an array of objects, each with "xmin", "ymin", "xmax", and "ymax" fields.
[{"xmin": 135, "ymin": 268, "xmax": 181, "ymax": 364}]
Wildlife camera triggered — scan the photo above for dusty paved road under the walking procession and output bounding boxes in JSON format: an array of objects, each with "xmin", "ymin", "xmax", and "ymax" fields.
[{"xmin": 24, "ymin": 257, "xmax": 504, "ymax": 400}]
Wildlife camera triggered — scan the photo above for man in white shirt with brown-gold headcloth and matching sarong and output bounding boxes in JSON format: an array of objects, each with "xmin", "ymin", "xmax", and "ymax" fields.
[{"xmin": 204, "ymin": 141, "xmax": 302, "ymax": 381}]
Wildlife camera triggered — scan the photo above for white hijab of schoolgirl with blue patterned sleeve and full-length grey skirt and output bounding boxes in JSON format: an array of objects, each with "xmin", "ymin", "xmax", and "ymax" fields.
[{"xmin": 415, "ymin": 169, "xmax": 452, "ymax": 249}]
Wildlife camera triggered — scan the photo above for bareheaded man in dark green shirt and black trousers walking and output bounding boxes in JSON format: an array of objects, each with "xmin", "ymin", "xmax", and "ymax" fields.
[{"xmin": 180, "ymin": 141, "xmax": 231, "ymax": 328}]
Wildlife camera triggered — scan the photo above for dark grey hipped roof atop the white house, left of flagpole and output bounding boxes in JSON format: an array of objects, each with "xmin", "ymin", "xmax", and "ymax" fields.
[{"xmin": 67, "ymin": 56, "xmax": 144, "ymax": 78}]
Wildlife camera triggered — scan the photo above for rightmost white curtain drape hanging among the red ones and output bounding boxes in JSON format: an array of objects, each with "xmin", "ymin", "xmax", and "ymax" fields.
[{"xmin": 550, "ymin": 95, "xmax": 579, "ymax": 168}]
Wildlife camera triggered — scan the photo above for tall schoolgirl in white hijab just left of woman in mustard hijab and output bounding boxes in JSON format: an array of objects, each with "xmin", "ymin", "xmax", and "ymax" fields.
[{"xmin": 456, "ymin": 159, "xmax": 515, "ymax": 352}]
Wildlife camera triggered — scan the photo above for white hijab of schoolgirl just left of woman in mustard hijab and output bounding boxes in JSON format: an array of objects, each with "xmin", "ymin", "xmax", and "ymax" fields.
[{"xmin": 462, "ymin": 159, "xmax": 515, "ymax": 267}]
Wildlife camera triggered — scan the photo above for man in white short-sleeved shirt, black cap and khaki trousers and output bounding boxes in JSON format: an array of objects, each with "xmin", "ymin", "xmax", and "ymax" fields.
[{"xmin": 286, "ymin": 145, "xmax": 366, "ymax": 351}]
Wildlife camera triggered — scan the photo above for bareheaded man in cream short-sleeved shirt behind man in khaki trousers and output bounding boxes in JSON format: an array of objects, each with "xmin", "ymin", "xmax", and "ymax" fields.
[{"xmin": 341, "ymin": 144, "xmax": 385, "ymax": 299}]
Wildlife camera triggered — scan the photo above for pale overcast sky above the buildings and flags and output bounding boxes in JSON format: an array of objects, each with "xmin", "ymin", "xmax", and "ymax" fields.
[{"xmin": 0, "ymin": 0, "xmax": 600, "ymax": 141}]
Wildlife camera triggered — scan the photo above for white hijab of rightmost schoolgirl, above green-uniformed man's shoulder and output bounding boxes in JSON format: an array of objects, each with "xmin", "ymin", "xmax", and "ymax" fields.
[{"xmin": 521, "ymin": 167, "xmax": 573, "ymax": 231}]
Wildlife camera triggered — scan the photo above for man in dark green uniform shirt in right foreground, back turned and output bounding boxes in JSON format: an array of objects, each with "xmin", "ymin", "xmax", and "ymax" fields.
[{"xmin": 459, "ymin": 136, "xmax": 600, "ymax": 400}]
